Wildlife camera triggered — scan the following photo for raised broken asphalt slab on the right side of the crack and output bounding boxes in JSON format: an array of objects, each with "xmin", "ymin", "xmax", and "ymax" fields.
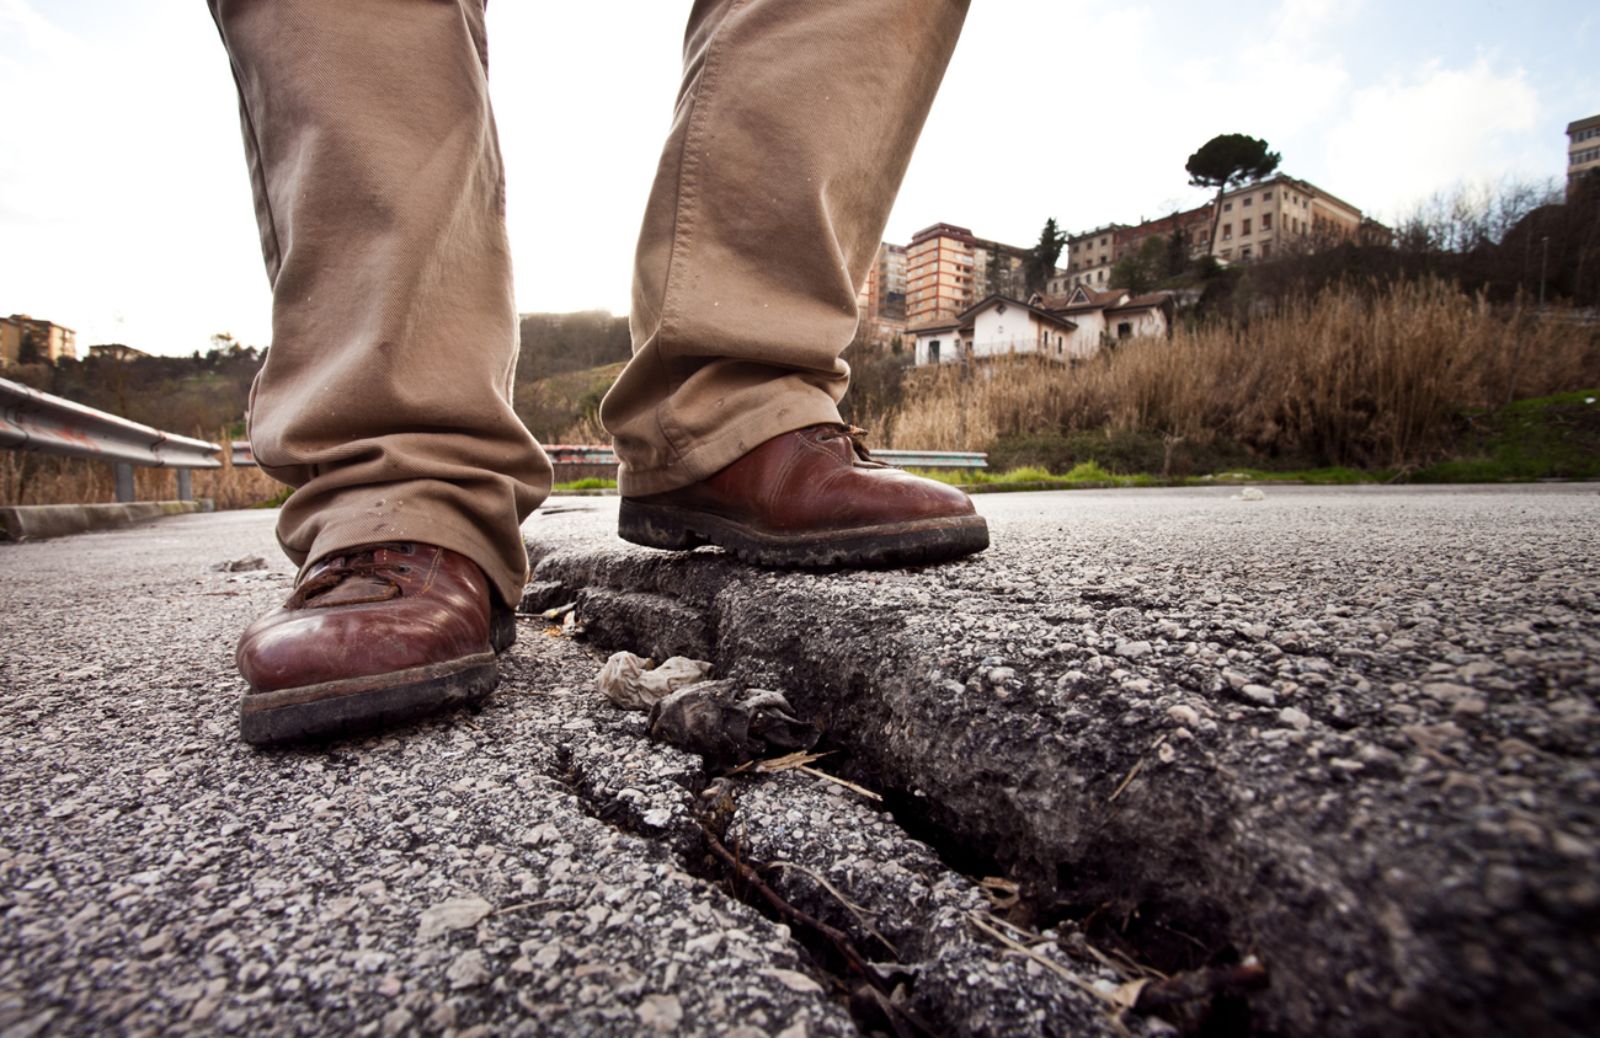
[{"xmin": 526, "ymin": 485, "xmax": 1600, "ymax": 1035}]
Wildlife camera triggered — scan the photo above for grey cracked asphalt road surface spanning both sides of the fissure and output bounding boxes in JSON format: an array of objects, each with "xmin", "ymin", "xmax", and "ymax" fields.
[{"xmin": 0, "ymin": 485, "xmax": 1600, "ymax": 1038}]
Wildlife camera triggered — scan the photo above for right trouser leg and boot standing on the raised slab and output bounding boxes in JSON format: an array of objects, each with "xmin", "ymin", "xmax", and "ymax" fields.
[{"xmin": 602, "ymin": 0, "xmax": 987, "ymax": 565}]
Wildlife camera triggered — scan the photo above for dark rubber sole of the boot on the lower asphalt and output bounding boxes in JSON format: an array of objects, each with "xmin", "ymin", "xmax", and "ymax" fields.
[{"xmin": 238, "ymin": 608, "xmax": 517, "ymax": 745}]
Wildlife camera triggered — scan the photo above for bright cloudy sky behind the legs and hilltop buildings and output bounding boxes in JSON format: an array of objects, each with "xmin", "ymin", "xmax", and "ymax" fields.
[{"xmin": 0, "ymin": 0, "xmax": 1600, "ymax": 353}]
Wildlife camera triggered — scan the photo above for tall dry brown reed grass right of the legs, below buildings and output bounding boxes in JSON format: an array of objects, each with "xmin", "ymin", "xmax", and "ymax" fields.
[{"xmin": 864, "ymin": 281, "xmax": 1600, "ymax": 467}]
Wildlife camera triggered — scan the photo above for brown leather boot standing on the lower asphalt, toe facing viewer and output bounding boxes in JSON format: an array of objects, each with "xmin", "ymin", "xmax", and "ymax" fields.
[{"xmin": 235, "ymin": 542, "xmax": 517, "ymax": 744}]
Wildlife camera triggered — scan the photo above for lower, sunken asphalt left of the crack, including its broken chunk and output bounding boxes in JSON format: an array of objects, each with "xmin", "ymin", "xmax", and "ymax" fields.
[{"xmin": 0, "ymin": 513, "xmax": 1132, "ymax": 1038}]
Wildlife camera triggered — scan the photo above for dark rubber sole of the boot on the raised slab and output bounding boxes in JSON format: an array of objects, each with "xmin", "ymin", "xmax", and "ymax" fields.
[{"xmin": 618, "ymin": 497, "xmax": 989, "ymax": 569}]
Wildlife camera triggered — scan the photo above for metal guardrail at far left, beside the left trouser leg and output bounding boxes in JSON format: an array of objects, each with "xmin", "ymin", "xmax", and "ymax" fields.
[{"xmin": 0, "ymin": 379, "xmax": 222, "ymax": 501}]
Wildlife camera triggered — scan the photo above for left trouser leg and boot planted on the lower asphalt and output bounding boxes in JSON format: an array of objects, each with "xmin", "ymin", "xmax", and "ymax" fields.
[{"xmin": 211, "ymin": 0, "xmax": 550, "ymax": 741}]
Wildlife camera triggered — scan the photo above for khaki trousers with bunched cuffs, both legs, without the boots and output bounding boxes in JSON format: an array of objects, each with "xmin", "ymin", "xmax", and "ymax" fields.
[{"xmin": 210, "ymin": 0, "xmax": 966, "ymax": 603}]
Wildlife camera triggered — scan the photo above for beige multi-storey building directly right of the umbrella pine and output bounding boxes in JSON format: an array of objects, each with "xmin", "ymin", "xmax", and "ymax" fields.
[{"xmin": 1211, "ymin": 176, "xmax": 1363, "ymax": 262}]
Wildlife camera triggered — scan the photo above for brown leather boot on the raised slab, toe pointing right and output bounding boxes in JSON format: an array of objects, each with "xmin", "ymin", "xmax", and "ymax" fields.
[{"xmin": 618, "ymin": 424, "xmax": 989, "ymax": 568}]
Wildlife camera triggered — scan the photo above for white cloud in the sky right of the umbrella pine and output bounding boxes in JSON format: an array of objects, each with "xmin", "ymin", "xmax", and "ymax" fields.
[{"xmin": 1326, "ymin": 58, "xmax": 1547, "ymax": 216}]
